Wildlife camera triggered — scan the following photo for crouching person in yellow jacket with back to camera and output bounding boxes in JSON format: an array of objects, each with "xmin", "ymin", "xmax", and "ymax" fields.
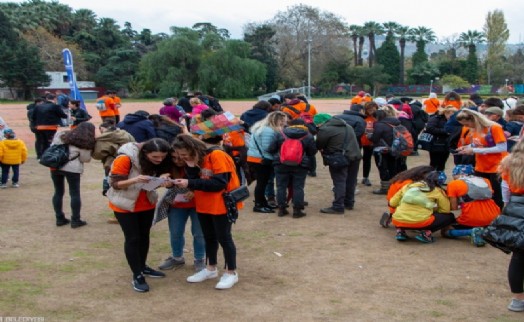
[{"xmin": 390, "ymin": 171, "xmax": 455, "ymax": 243}]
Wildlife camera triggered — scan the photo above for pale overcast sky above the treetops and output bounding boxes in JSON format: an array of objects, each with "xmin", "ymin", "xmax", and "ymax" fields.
[{"xmin": 7, "ymin": 0, "xmax": 524, "ymax": 43}]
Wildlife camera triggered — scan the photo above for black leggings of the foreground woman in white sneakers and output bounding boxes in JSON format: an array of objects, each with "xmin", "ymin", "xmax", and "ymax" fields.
[{"xmin": 198, "ymin": 213, "xmax": 237, "ymax": 271}]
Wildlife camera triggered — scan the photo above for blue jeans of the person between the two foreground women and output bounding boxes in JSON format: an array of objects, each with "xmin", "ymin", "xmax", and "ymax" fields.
[{"xmin": 167, "ymin": 208, "xmax": 206, "ymax": 259}]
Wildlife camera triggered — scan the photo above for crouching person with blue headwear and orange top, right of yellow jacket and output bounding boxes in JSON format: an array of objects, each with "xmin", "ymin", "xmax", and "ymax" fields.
[{"xmin": 441, "ymin": 164, "xmax": 500, "ymax": 247}]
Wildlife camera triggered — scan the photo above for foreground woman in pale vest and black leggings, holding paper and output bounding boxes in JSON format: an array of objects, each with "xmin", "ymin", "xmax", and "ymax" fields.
[{"xmin": 107, "ymin": 138, "xmax": 171, "ymax": 292}]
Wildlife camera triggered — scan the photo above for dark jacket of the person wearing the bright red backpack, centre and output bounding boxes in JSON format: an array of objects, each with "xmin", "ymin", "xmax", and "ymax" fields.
[{"xmin": 268, "ymin": 125, "xmax": 317, "ymax": 169}]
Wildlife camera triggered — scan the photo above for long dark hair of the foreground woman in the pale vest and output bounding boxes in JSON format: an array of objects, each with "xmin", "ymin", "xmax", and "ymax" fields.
[{"xmin": 138, "ymin": 138, "xmax": 172, "ymax": 176}]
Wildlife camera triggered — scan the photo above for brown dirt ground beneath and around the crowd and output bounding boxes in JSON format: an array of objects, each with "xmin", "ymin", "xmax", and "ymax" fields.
[{"xmin": 0, "ymin": 100, "xmax": 524, "ymax": 322}]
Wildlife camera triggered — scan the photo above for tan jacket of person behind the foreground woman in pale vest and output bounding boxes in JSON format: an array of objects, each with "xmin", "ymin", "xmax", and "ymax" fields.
[{"xmin": 92, "ymin": 129, "xmax": 135, "ymax": 169}]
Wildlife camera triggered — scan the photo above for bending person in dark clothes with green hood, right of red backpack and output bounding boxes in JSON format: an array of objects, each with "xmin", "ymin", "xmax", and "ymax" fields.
[{"xmin": 314, "ymin": 113, "xmax": 362, "ymax": 214}]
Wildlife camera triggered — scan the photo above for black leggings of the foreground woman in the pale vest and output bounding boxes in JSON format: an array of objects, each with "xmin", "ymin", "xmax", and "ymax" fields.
[{"xmin": 115, "ymin": 209, "xmax": 155, "ymax": 277}]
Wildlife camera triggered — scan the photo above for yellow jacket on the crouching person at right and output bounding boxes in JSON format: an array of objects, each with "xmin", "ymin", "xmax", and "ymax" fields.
[{"xmin": 389, "ymin": 182, "xmax": 451, "ymax": 225}]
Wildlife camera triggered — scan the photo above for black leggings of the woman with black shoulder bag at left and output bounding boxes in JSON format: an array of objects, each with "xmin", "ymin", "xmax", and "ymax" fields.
[{"xmin": 51, "ymin": 170, "xmax": 82, "ymax": 221}]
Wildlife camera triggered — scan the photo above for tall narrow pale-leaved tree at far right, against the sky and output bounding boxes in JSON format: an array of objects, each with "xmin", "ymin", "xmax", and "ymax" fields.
[{"xmin": 483, "ymin": 9, "xmax": 509, "ymax": 84}]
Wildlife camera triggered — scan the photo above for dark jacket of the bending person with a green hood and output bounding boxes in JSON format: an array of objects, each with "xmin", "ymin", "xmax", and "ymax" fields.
[{"xmin": 316, "ymin": 116, "xmax": 362, "ymax": 161}]
